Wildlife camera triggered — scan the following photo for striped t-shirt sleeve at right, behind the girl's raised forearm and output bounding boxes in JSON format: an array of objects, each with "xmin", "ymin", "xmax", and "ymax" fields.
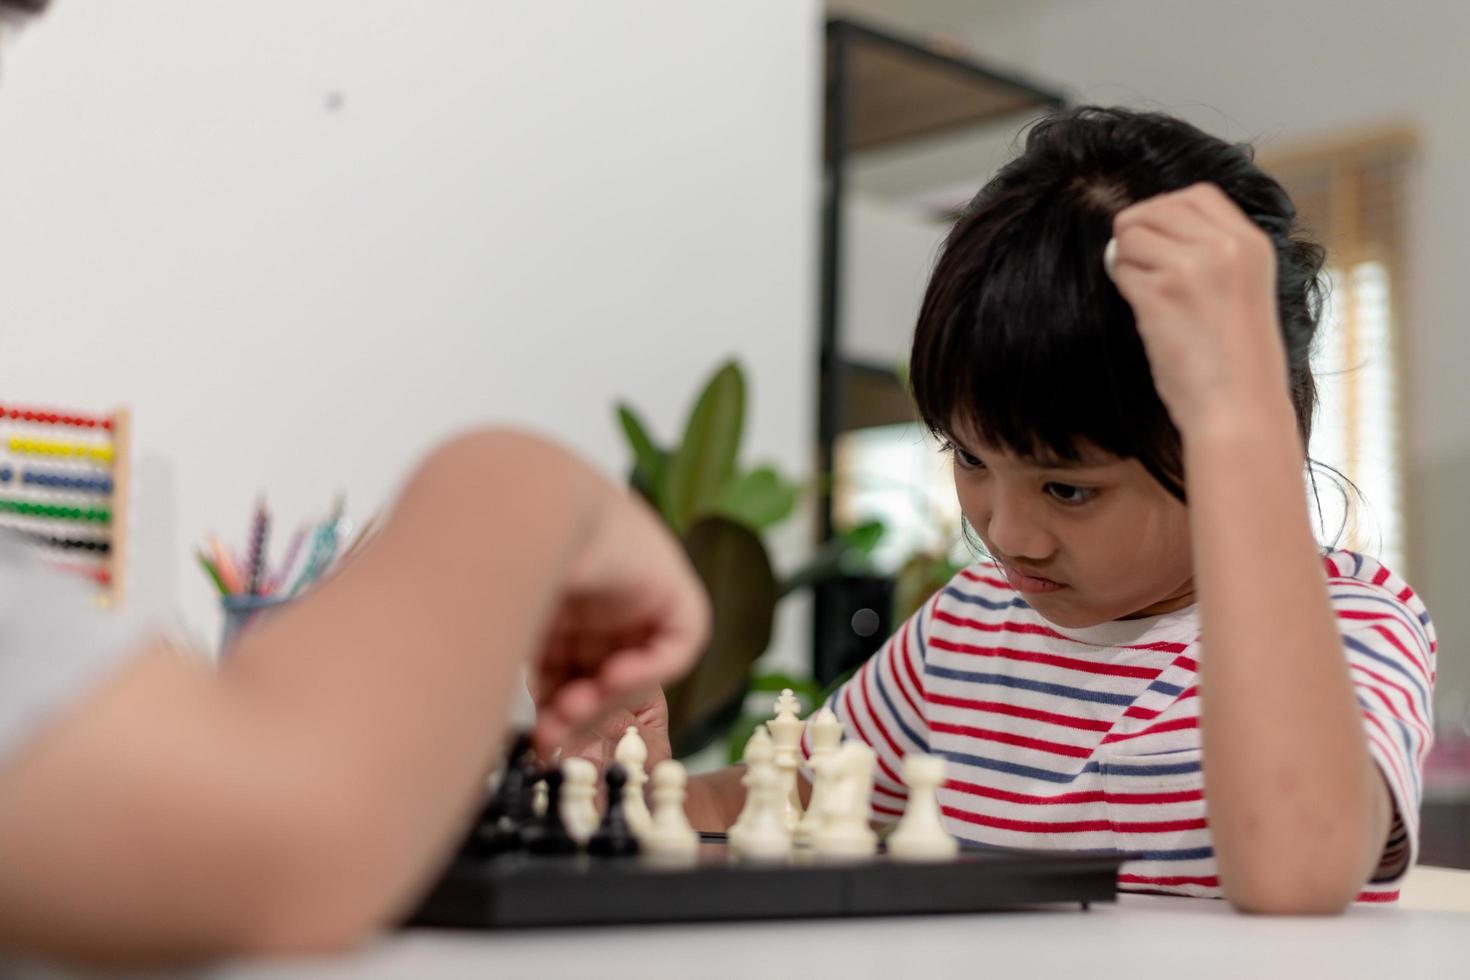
[{"xmin": 1326, "ymin": 551, "xmax": 1438, "ymax": 886}]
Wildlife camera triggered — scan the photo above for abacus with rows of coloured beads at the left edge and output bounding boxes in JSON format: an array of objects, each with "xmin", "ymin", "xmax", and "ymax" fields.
[{"xmin": 0, "ymin": 404, "xmax": 129, "ymax": 605}]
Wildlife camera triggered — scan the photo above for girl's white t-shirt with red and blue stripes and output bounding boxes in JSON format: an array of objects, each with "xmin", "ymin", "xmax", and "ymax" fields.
[{"xmin": 806, "ymin": 551, "xmax": 1436, "ymax": 902}]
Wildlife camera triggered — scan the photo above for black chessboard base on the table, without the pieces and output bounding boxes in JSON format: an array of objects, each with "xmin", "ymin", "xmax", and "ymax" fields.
[{"xmin": 406, "ymin": 835, "xmax": 1126, "ymax": 929}]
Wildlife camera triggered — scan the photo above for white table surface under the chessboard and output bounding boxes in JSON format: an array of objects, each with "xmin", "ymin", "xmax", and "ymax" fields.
[{"xmin": 14, "ymin": 895, "xmax": 1470, "ymax": 980}]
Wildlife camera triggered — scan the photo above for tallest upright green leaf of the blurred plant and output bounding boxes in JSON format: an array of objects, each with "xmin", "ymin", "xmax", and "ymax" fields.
[{"xmin": 659, "ymin": 361, "xmax": 745, "ymax": 532}]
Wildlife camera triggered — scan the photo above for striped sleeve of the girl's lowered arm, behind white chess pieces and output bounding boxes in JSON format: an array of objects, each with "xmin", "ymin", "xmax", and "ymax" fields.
[{"xmin": 801, "ymin": 599, "xmax": 936, "ymax": 824}]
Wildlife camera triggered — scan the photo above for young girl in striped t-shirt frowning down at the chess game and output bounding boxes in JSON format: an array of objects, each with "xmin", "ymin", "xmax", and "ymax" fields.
[{"xmin": 585, "ymin": 107, "xmax": 1435, "ymax": 912}]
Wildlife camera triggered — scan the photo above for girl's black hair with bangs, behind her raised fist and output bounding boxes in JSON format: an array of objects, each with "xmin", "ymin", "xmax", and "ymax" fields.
[{"xmin": 910, "ymin": 106, "xmax": 1324, "ymax": 500}]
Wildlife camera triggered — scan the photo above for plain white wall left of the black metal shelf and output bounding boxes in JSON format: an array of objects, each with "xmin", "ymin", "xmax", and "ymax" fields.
[{"xmin": 0, "ymin": 0, "xmax": 820, "ymax": 658}]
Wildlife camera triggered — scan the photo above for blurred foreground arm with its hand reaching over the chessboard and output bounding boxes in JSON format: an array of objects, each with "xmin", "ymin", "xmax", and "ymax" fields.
[{"xmin": 0, "ymin": 432, "xmax": 709, "ymax": 961}]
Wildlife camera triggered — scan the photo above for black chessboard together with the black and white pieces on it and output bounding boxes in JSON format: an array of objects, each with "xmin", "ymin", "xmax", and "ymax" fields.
[{"xmin": 407, "ymin": 691, "xmax": 1127, "ymax": 929}]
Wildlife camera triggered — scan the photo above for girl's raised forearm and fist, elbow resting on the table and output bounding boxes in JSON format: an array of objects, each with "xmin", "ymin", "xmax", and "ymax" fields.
[{"xmin": 1114, "ymin": 185, "xmax": 1392, "ymax": 912}]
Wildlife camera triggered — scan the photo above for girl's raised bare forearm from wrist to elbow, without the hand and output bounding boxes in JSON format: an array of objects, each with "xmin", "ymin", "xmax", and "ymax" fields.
[{"xmin": 1185, "ymin": 397, "xmax": 1392, "ymax": 912}]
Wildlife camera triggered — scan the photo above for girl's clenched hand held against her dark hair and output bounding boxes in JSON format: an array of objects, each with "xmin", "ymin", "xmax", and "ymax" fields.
[{"xmin": 1108, "ymin": 184, "xmax": 1289, "ymax": 435}]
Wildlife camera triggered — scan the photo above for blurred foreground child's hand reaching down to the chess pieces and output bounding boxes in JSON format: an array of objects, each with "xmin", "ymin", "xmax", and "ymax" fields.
[{"xmin": 531, "ymin": 491, "xmax": 710, "ymax": 761}]
